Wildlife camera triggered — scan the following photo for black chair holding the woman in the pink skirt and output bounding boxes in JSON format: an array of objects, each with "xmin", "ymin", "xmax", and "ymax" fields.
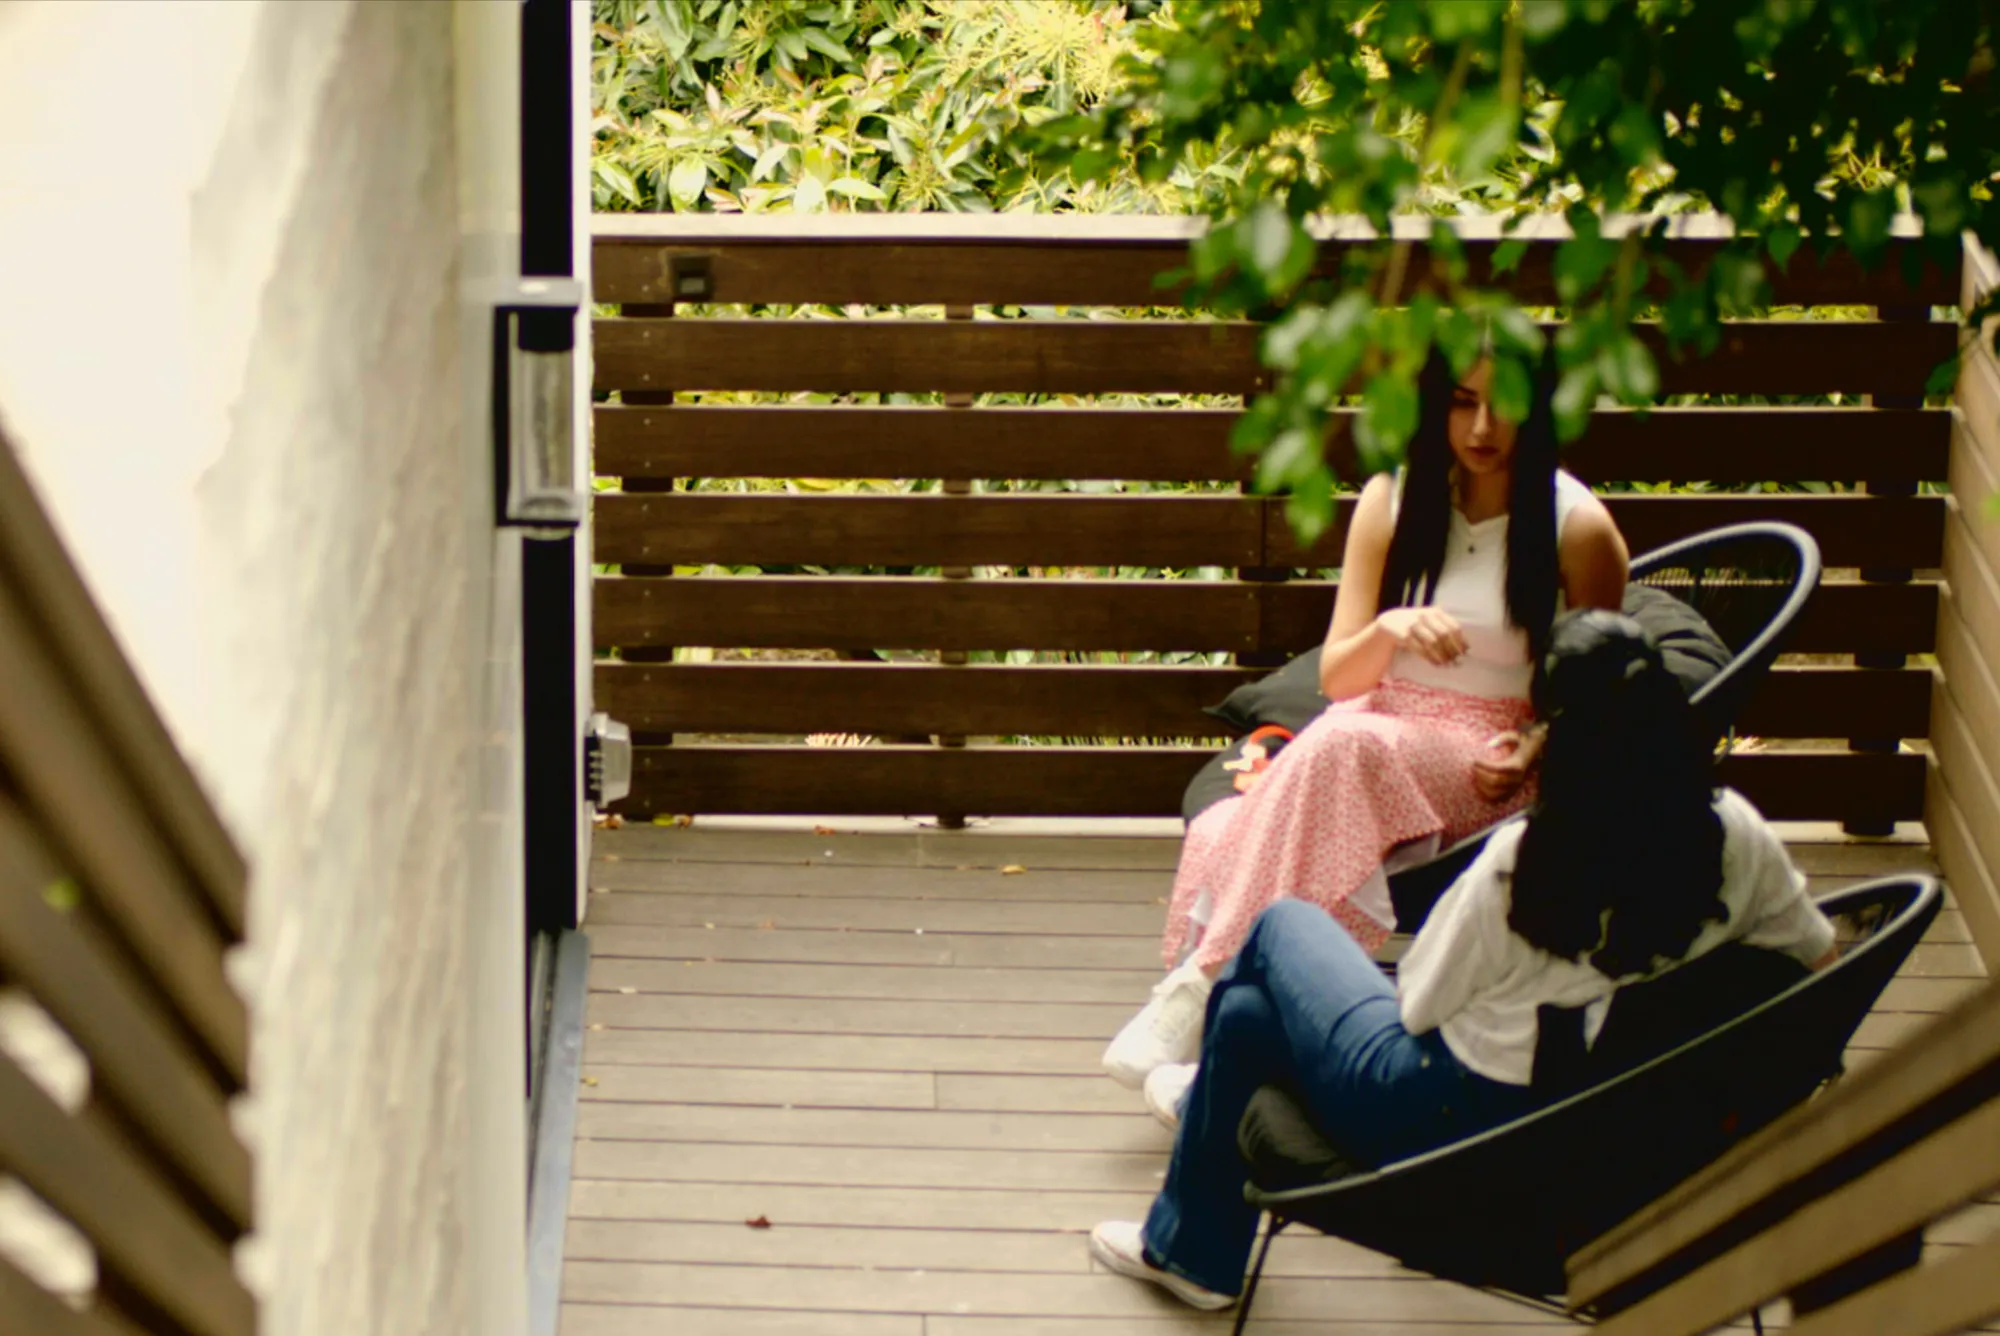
[{"xmin": 1388, "ymin": 524, "xmax": 1820, "ymax": 932}]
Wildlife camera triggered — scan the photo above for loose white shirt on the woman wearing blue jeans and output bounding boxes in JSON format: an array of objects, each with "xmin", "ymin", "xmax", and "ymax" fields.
[{"xmin": 1396, "ymin": 788, "xmax": 1834, "ymax": 1086}]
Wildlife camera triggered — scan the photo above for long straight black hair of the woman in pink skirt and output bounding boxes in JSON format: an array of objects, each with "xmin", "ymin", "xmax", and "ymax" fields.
[{"xmin": 1378, "ymin": 350, "xmax": 1562, "ymax": 654}]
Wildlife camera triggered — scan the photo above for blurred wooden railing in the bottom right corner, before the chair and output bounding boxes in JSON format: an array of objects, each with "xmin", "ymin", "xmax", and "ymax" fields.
[{"xmin": 1570, "ymin": 984, "xmax": 2000, "ymax": 1336}]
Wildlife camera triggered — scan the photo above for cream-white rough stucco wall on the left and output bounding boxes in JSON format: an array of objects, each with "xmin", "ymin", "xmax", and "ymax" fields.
[{"xmin": 0, "ymin": 0, "xmax": 522, "ymax": 1336}]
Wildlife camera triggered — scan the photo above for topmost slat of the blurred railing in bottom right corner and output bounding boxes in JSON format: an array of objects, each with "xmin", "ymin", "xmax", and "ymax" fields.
[{"xmin": 1568, "ymin": 984, "xmax": 2000, "ymax": 1304}]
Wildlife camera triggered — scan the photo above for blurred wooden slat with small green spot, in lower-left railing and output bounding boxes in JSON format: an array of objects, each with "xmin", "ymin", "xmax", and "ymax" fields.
[{"xmin": 0, "ymin": 794, "xmax": 250, "ymax": 1232}]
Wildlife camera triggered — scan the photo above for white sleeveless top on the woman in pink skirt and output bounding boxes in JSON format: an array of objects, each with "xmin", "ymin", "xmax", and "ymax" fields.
[{"xmin": 1382, "ymin": 468, "xmax": 1590, "ymax": 700}]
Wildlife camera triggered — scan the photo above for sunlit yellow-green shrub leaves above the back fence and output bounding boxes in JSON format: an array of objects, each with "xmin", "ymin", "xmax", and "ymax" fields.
[{"xmin": 592, "ymin": 0, "xmax": 1232, "ymax": 214}]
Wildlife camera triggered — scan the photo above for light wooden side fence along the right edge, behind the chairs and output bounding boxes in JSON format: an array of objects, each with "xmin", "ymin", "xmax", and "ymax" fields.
[{"xmin": 1924, "ymin": 237, "xmax": 2000, "ymax": 974}]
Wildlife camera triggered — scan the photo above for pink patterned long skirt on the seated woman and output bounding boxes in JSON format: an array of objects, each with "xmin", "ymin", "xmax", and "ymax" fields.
[{"xmin": 1160, "ymin": 678, "xmax": 1534, "ymax": 970}]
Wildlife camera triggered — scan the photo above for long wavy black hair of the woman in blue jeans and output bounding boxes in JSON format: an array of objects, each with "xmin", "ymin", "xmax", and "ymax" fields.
[{"xmin": 1508, "ymin": 608, "xmax": 1728, "ymax": 978}]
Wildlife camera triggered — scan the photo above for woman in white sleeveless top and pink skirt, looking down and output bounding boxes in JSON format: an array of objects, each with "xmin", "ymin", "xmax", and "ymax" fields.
[{"xmin": 1104, "ymin": 356, "xmax": 1626, "ymax": 1086}]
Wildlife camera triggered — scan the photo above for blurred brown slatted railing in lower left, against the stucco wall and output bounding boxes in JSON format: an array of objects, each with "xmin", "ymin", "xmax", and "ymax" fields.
[{"xmin": 0, "ymin": 438, "xmax": 256, "ymax": 1336}]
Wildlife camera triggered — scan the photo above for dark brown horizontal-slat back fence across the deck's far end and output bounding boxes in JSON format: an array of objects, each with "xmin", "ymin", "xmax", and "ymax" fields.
[{"xmin": 594, "ymin": 216, "xmax": 1960, "ymax": 828}]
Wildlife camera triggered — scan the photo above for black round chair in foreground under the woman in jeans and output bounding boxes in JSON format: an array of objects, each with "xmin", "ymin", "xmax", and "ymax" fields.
[{"xmin": 1236, "ymin": 874, "xmax": 1944, "ymax": 1332}]
